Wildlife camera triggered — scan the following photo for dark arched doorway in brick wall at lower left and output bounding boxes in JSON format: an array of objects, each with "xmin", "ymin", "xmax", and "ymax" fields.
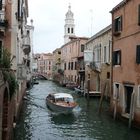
[{"xmin": 2, "ymin": 88, "xmax": 8, "ymax": 140}]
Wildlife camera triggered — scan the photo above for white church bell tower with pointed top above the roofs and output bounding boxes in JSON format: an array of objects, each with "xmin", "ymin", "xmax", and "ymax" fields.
[{"xmin": 64, "ymin": 5, "xmax": 75, "ymax": 44}]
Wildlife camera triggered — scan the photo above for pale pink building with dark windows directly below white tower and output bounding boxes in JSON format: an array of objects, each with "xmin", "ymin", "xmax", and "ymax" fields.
[{"xmin": 61, "ymin": 37, "xmax": 88, "ymax": 84}]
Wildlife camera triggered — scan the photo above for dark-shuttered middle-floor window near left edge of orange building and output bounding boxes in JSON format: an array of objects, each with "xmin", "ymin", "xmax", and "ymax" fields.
[{"xmin": 113, "ymin": 50, "xmax": 121, "ymax": 65}]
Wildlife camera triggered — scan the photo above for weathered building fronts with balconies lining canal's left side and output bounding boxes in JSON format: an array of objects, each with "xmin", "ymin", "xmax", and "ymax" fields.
[{"xmin": 0, "ymin": 0, "xmax": 31, "ymax": 140}]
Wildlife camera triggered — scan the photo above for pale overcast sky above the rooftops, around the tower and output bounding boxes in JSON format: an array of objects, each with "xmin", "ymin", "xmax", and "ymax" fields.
[{"xmin": 28, "ymin": 0, "xmax": 122, "ymax": 53}]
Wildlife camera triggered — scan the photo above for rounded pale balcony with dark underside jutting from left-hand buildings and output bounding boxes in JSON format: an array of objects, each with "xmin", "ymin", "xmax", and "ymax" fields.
[{"xmin": 22, "ymin": 36, "xmax": 31, "ymax": 55}]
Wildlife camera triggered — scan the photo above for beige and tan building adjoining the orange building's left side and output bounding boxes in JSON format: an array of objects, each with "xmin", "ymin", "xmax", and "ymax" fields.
[{"xmin": 84, "ymin": 25, "xmax": 112, "ymax": 95}]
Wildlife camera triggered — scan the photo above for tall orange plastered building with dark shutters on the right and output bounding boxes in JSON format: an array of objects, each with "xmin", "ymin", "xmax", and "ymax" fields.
[{"xmin": 111, "ymin": 0, "xmax": 140, "ymax": 124}]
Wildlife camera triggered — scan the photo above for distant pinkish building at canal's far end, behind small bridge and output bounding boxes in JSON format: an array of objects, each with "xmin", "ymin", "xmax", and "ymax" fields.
[{"xmin": 37, "ymin": 53, "xmax": 53, "ymax": 79}]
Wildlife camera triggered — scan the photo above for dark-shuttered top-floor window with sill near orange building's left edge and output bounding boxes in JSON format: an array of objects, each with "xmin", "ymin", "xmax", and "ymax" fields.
[{"xmin": 114, "ymin": 16, "xmax": 122, "ymax": 33}]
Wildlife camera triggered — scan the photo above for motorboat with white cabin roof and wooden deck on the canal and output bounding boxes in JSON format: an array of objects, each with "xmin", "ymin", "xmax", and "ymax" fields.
[{"xmin": 46, "ymin": 93, "xmax": 77, "ymax": 113}]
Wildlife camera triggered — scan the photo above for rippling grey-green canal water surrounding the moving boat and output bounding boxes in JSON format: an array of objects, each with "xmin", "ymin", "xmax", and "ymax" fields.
[{"xmin": 14, "ymin": 81, "xmax": 140, "ymax": 140}]
